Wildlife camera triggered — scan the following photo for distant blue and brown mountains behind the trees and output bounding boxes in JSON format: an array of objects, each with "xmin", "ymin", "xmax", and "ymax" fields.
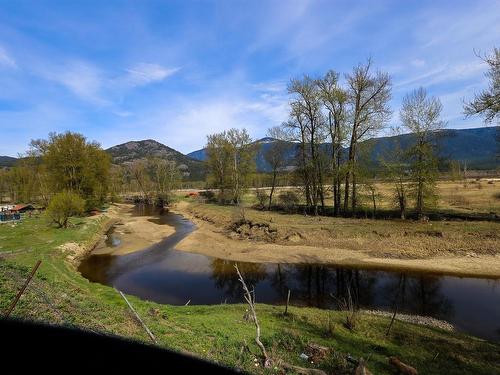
[{"xmin": 0, "ymin": 126, "xmax": 500, "ymax": 180}]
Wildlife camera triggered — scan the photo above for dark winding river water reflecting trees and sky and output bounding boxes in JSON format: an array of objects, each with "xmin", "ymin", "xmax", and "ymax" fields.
[{"xmin": 79, "ymin": 207, "xmax": 500, "ymax": 340}]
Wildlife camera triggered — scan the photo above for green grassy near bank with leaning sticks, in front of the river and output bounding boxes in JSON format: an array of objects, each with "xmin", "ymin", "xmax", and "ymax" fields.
[{"xmin": 0, "ymin": 216, "xmax": 500, "ymax": 374}]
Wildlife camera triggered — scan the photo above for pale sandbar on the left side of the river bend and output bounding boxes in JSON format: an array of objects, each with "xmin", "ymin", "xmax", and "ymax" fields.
[{"xmin": 93, "ymin": 204, "xmax": 175, "ymax": 255}]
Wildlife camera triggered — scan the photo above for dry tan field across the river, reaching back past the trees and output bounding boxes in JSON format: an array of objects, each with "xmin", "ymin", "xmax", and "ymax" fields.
[{"xmin": 175, "ymin": 180, "xmax": 500, "ymax": 273}]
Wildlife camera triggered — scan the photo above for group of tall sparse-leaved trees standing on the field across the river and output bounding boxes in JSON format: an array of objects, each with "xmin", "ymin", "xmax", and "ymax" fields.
[{"xmin": 207, "ymin": 60, "xmax": 445, "ymax": 217}]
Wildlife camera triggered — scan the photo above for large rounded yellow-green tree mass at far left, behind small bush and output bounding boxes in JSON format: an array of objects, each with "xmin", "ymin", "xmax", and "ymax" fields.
[{"xmin": 0, "ymin": 132, "xmax": 111, "ymax": 209}]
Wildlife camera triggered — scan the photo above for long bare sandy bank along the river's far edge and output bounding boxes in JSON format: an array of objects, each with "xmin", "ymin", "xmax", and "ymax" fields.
[{"xmin": 174, "ymin": 202, "xmax": 500, "ymax": 277}]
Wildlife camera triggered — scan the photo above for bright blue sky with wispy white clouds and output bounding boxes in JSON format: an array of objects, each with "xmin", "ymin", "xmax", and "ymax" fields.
[{"xmin": 0, "ymin": 0, "xmax": 500, "ymax": 156}]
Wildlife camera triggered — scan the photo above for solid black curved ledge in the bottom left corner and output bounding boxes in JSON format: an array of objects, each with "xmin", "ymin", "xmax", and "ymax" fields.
[{"xmin": 0, "ymin": 319, "xmax": 240, "ymax": 375}]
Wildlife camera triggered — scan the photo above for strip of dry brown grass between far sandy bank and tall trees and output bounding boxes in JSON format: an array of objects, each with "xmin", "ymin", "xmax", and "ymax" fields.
[{"xmin": 180, "ymin": 202, "xmax": 500, "ymax": 258}]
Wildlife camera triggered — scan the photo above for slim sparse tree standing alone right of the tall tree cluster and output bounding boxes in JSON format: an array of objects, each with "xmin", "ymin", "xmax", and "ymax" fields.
[{"xmin": 400, "ymin": 88, "xmax": 445, "ymax": 215}]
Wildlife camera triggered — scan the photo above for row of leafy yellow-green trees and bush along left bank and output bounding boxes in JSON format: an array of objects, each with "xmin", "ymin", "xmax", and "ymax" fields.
[{"xmin": 0, "ymin": 132, "xmax": 181, "ymax": 226}]
